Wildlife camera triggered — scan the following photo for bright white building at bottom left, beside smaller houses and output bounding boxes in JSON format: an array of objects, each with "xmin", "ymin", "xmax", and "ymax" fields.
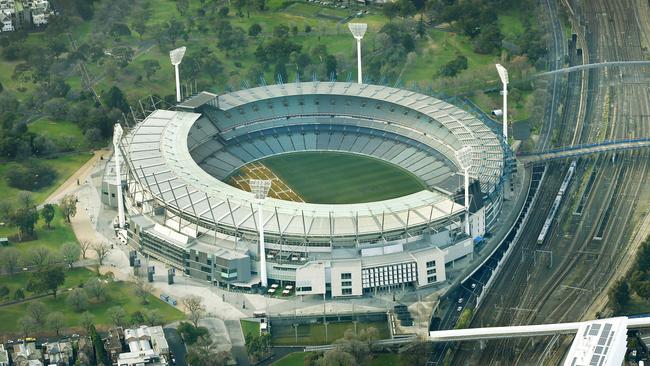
[{"xmin": 117, "ymin": 325, "xmax": 169, "ymax": 366}]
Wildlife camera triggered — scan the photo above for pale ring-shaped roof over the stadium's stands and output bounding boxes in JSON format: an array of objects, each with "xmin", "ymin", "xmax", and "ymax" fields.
[{"xmin": 122, "ymin": 82, "xmax": 503, "ymax": 237}]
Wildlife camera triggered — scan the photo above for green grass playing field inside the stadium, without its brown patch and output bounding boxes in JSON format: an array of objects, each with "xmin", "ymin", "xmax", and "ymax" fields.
[{"xmin": 251, "ymin": 152, "xmax": 426, "ymax": 204}]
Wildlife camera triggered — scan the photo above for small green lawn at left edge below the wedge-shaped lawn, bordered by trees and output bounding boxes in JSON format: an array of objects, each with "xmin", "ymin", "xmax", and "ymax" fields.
[{"xmin": 0, "ymin": 206, "xmax": 77, "ymax": 255}]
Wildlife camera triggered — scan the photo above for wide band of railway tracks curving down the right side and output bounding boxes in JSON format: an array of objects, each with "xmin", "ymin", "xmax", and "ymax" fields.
[{"xmin": 452, "ymin": 0, "xmax": 650, "ymax": 365}]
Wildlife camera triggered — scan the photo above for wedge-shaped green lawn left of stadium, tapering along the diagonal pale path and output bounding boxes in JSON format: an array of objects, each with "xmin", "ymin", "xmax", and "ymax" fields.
[{"xmin": 0, "ymin": 153, "xmax": 92, "ymax": 204}]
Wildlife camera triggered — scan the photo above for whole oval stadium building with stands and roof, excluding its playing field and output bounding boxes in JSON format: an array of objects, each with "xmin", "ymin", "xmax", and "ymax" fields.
[{"xmin": 102, "ymin": 82, "xmax": 505, "ymax": 297}]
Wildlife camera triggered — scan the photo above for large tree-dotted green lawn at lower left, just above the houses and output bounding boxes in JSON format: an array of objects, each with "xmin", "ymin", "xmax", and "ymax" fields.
[{"xmin": 0, "ymin": 270, "xmax": 185, "ymax": 335}]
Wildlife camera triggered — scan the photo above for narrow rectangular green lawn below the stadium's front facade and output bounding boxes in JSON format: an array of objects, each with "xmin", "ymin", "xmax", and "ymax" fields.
[{"xmin": 271, "ymin": 322, "xmax": 390, "ymax": 346}]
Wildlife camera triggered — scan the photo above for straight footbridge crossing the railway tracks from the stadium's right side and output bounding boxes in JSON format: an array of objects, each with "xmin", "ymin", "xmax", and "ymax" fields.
[{"xmin": 517, "ymin": 137, "xmax": 650, "ymax": 164}]
